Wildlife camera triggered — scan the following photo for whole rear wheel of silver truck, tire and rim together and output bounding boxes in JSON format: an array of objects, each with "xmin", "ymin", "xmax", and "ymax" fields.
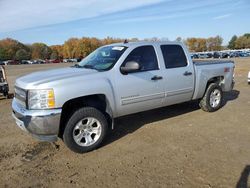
[{"xmin": 199, "ymin": 83, "xmax": 223, "ymax": 112}]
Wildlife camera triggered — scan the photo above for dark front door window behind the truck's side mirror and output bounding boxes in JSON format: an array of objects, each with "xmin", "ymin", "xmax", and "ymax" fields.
[{"xmin": 123, "ymin": 46, "xmax": 159, "ymax": 72}]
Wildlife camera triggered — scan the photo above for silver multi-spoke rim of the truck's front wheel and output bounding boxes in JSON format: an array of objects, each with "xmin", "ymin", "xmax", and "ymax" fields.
[{"xmin": 73, "ymin": 117, "xmax": 102, "ymax": 146}]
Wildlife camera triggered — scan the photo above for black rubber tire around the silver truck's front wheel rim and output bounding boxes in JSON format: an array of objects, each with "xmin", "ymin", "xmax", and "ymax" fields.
[{"xmin": 63, "ymin": 107, "xmax": 108, "ymax": 153}]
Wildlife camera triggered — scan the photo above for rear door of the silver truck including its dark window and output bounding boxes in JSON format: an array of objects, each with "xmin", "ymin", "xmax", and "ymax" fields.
[{"xmin": 160, "ymin": 44, "xmax": 194, "ymax": 105}]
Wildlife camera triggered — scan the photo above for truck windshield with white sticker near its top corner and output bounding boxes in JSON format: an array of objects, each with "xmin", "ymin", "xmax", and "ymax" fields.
[{"xmin": 75, "ymin": 46, "xmax": 127, "ymax": 71}]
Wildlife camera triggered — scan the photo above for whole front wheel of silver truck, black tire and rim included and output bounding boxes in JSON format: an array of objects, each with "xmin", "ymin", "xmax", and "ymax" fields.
[{"xmin": 63, "ymin": 107, "xmax": 108, "ymax": 153}]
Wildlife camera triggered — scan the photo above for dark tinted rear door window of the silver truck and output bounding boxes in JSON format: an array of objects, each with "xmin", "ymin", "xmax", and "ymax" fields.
[{"xmin": 161, "ymin": 45, "xmax": 187, "ymax": 69}]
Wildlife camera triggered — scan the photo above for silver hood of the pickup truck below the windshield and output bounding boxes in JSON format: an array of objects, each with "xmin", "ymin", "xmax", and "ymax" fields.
[{"xmin": 16, "ymin": 67, "xmax": 98, "ymax": 89}]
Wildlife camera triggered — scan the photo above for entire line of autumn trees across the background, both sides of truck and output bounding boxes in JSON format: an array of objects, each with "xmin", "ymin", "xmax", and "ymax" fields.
[{"xmin": 0, "ymin": 33, "xmax": 250, "ymax": 61}]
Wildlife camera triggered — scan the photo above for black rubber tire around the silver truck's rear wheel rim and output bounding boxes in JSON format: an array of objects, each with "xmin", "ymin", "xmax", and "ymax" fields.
[{"xmin": 199, "ymin": 83, "xmax": 223, "ymax": 112}]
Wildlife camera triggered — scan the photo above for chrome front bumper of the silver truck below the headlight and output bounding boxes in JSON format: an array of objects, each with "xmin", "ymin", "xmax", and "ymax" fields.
[{"xmin": 12, "ymin": 98, "xmax": 62, "ymax": 142}]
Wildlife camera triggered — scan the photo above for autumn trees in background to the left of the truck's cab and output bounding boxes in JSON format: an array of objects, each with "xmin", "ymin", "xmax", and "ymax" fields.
[{"xmin": 0, "ymin": 37, "xmax": 123, "ymax": 61}]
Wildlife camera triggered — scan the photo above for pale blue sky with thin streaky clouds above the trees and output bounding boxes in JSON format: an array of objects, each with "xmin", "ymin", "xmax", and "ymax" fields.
[{"xmin": 0, "ymin": 0, "xmax": 250, "ymax": 44}]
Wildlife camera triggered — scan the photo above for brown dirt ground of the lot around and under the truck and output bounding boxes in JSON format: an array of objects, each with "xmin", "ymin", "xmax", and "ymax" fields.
[{"xmin": 0, "ymin": 58, "xmax": 250, "ymax": 188}]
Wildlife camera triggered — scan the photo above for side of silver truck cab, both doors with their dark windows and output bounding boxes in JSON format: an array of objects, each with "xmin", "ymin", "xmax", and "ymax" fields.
[{"xmin": 113, "ymin": 42, "xmax": 195, "ymax": 116}]
